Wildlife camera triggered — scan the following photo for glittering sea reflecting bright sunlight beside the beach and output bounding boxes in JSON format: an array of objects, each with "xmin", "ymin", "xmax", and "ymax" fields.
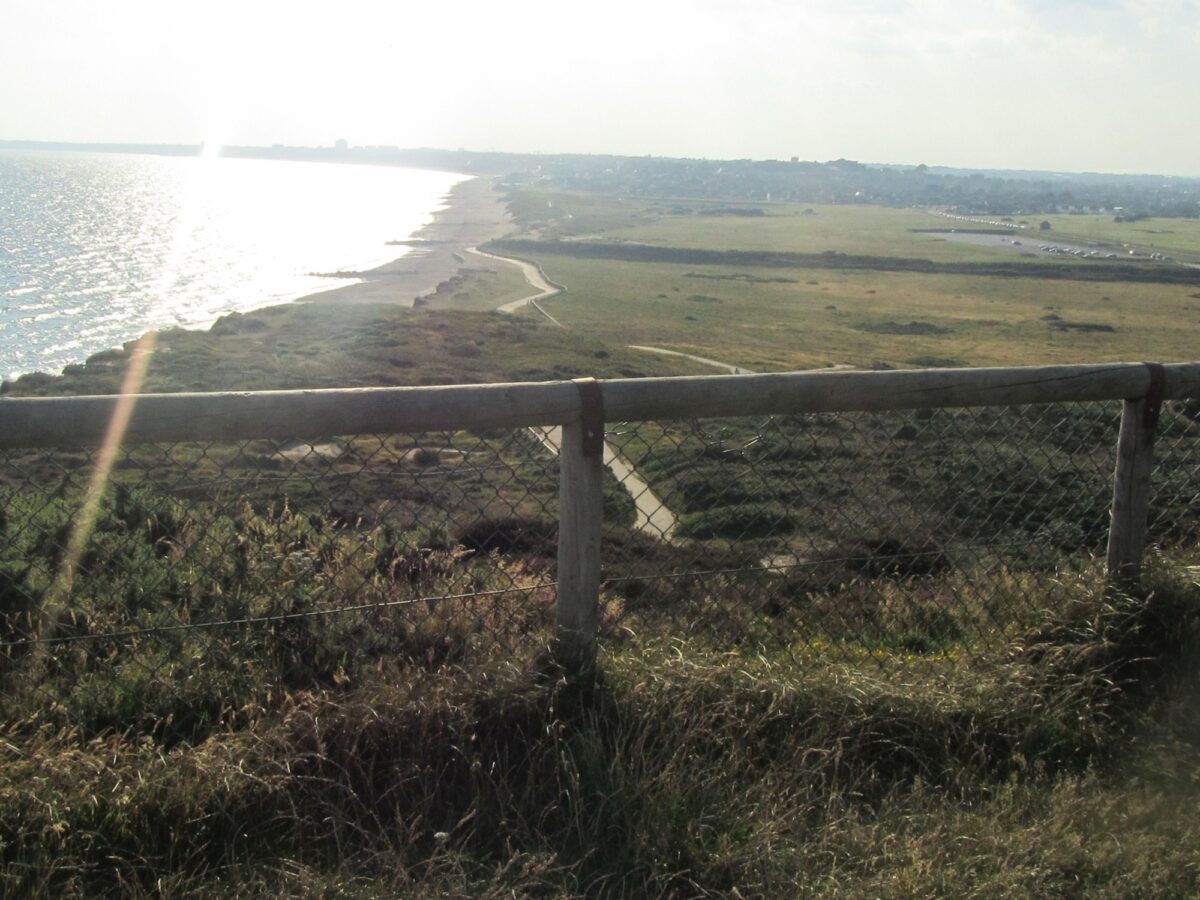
[{"xmin": 0, "ymin": 150, "xmax": 463, "ymax": 377}]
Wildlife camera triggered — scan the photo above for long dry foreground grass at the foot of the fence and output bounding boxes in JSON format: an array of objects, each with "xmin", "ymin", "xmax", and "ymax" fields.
[{"xmin": 0, "ymin": 547, "xmax": 1200, "ymax": 898}]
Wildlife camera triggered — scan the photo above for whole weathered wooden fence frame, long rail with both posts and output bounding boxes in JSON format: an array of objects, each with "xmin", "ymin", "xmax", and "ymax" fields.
[{"xmin": 0, "ymin": 362, "xmax": 1200, "ymax": 671}]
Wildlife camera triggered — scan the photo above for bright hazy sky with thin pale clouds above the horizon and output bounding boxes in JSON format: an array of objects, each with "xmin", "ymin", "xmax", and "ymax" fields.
[{"xmin": 0, "ymin": 0, "xmax": 1200, "ymax": 176}]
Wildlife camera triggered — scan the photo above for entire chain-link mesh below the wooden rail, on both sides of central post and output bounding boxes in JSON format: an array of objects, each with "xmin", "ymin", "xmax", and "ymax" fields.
[{"xmin": 0, "ymin": 376, "xmax": 1200, "ymax": 743}]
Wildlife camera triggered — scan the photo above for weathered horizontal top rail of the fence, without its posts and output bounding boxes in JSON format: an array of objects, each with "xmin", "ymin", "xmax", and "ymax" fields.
[{"xmin": 0, "ymin": 362, "xmax": 1200, "ymax": 448}]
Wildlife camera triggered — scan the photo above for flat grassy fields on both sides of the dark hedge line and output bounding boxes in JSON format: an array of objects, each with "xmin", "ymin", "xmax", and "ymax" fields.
[{"xmin": 484, "ymin": 192, "xmax": 1200, "ymax": 371}]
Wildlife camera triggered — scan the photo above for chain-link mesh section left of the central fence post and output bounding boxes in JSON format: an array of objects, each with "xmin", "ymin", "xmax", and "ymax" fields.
[{"xmin": 0, "ymin": 431, "xmax": 558, "ymax": 742}]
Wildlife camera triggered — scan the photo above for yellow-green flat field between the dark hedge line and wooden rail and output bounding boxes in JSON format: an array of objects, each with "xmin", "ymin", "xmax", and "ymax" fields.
[{"xmin": 482, "ymin": 254, "xmax": 1200, "ymax": 371}]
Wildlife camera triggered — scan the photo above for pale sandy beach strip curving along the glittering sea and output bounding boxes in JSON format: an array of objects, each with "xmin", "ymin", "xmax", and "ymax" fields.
[{"xmin": 296, "ymin": 178, "xmax": 512, "ymax": 306}]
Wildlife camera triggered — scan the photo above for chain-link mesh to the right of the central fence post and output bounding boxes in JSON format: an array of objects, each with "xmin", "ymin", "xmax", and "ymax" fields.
[{"xmin": 602, "ymin": 402, "xmax": 1200, "ymax": 665}]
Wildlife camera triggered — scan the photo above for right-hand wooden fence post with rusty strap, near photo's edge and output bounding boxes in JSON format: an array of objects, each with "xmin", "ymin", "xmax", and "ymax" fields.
[{"xmin": 1108, "ymin": 364, "xmax": 1166, "ymax": 588}]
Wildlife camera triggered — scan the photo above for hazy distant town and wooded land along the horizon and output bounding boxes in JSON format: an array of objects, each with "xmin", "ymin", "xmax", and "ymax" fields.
[{"xmin": 0, "ymin": 139, "xmax": 1200, "ymax": 221}]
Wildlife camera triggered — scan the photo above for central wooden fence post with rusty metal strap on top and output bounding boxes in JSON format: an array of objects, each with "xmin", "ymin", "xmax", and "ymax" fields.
[{"xmin": 554, "ymin": 378, "xmax": 604, "ymax": 677}]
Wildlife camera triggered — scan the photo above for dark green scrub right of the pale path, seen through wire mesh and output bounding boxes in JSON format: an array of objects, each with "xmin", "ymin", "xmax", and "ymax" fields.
[{"xmin": 604, "ymin": 404, "xmax": 1128, "ymax": 553}]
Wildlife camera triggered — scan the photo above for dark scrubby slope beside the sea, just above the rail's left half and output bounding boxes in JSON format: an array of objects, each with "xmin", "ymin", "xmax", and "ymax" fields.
[{"xmin": 6, "ymin": 304, "xmax": 698, "ymax": 396}]
